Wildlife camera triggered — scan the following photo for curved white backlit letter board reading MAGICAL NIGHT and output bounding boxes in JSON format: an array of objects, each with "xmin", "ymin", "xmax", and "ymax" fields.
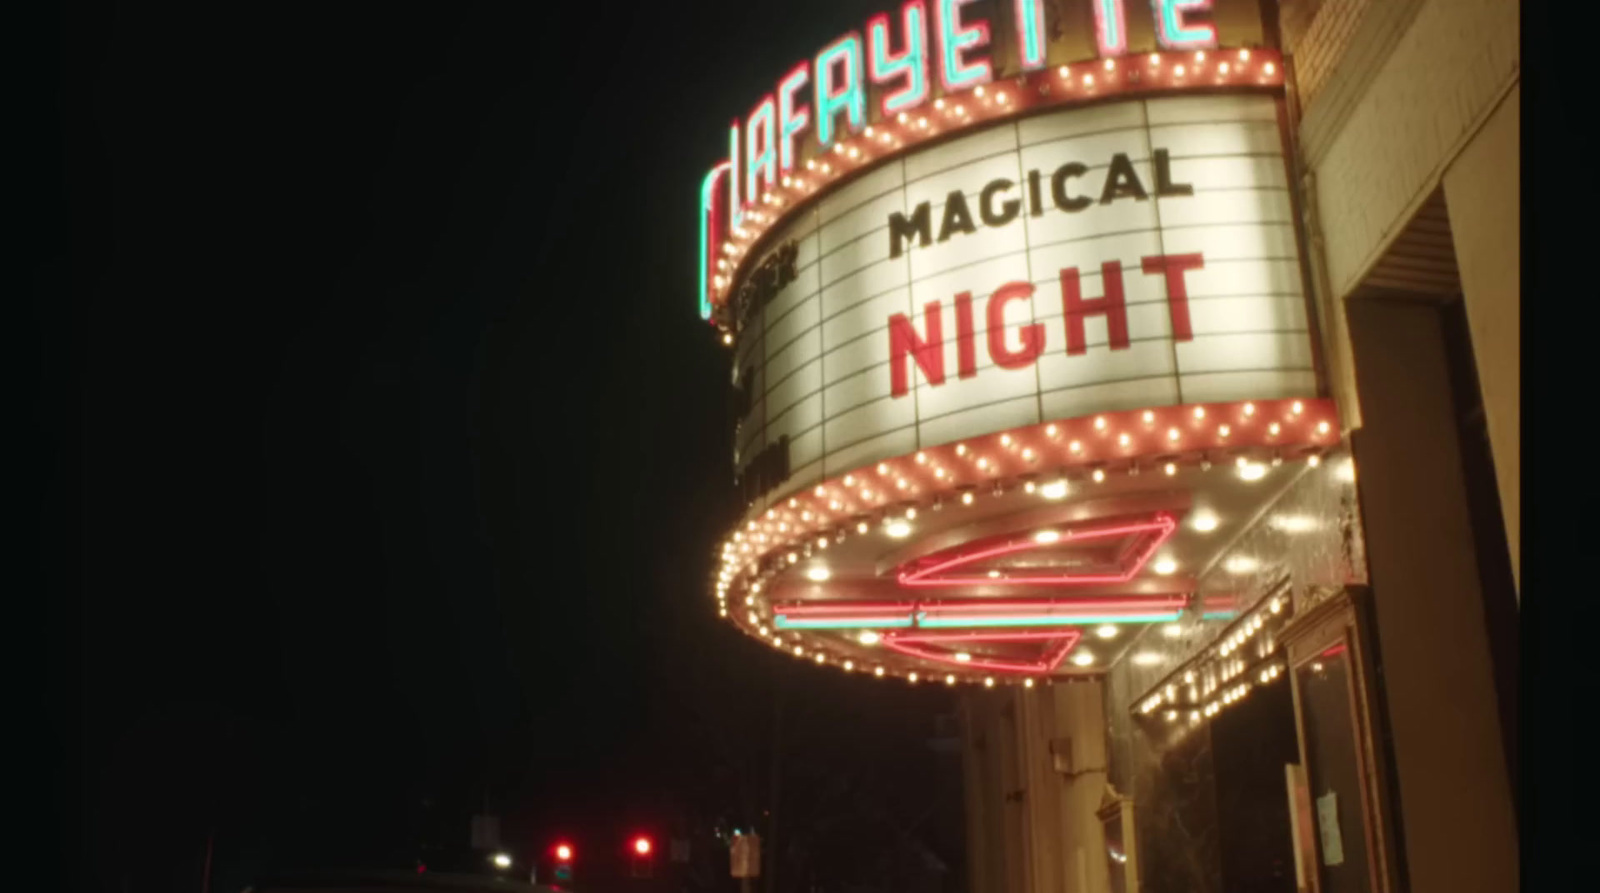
[{"xmin": 734, "ymin": 98, "xmax": 1317, "ymax": 508}]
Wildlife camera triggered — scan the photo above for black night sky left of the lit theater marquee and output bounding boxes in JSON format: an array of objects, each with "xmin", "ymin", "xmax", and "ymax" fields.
[{"xmin": 43, "ymin": 2, "xmax": 947, "ymax": 890}]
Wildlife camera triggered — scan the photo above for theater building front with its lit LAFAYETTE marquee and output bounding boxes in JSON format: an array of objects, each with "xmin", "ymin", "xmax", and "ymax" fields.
[{"xmin": 699, "ymin": 0, "xmax": 1520, "ymax": 893}]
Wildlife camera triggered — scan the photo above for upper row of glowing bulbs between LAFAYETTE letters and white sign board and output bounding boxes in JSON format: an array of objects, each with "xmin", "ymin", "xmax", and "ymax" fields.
[{"xmin": 712, "ymin": 50, "xmax": 1278, "ymax": 332}]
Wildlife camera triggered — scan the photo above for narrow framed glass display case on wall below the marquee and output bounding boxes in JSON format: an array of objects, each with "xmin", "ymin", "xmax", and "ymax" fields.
[{"xmin": 1296, "ymin": 642, "xmax": 1373, "ymax": 893}]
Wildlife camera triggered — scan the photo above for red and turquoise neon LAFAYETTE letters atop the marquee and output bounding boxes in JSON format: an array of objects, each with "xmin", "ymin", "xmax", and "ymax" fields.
[{"xmin": 698, "ymin": 0, "xmax": 1216, "ymax": 318}]
